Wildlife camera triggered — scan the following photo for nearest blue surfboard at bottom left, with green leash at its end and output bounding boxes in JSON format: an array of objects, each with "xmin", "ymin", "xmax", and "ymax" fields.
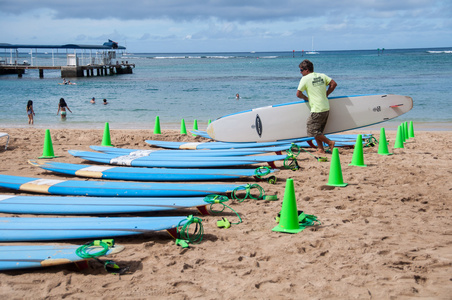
[{"xmin": 0, "ymin": 245, "xmax": 124, "ymax": 271}]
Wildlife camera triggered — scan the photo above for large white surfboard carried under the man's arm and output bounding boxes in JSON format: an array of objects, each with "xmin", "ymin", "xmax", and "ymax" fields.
[{"xmin": 207, "ymin": 94, "xmax": 413, "ymax": 142}]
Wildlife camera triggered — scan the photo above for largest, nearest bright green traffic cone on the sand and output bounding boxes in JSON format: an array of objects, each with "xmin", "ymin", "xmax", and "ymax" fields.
[{"xmin": 272, "ymin": 178, "xmax": 305, "ymax": 233}]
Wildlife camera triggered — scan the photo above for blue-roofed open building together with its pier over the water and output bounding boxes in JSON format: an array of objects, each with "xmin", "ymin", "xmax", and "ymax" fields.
[{"xmin": 0, "ymin": 40, "xmax": 135, "ymax": 78}]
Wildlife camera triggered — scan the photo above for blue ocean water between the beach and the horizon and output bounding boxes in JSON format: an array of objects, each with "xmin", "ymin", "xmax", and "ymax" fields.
[{"xmin": 0, "ymin": 48, "xmax": 452, "ymax": 129}]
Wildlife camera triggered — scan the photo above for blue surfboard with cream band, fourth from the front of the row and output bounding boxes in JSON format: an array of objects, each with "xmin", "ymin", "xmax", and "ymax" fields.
[{"xmin": 0, "ymin": 174, "xmax": 244, "ymax": 197}]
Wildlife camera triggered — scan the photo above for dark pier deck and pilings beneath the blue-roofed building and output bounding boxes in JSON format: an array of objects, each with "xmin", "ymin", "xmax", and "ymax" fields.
[{"xmin": 0, "ymin": 61, "xmax": 135, "ymax": 78}]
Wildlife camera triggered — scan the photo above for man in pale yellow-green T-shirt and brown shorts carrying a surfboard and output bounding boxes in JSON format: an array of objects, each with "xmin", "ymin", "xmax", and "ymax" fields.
[{"xmin": 297, "ymin": 59, "xmax": 337, "ymax": 154}]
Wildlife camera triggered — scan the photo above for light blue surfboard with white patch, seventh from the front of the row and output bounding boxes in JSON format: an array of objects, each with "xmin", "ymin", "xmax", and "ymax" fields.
[{"xmin": 90, "ymin": 146, "xmax": 287, "ymax": 159}]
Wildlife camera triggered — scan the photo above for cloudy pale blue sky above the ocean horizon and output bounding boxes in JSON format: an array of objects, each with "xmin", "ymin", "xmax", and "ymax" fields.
[{"xmin": 0, "ymin": 0, "xmax": 452, "ymax": 53}]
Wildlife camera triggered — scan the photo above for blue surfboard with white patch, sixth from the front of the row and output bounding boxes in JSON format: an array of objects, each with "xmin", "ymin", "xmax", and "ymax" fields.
[{"xmin": 68, "ymin": 150, "xmax": 287, "ymax": 168}]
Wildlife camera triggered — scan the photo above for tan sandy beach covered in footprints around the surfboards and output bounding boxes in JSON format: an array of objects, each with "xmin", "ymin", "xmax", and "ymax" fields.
[{"xmin": 0, "ymin": 128, "xmax": 452, "ymax": 300}]
